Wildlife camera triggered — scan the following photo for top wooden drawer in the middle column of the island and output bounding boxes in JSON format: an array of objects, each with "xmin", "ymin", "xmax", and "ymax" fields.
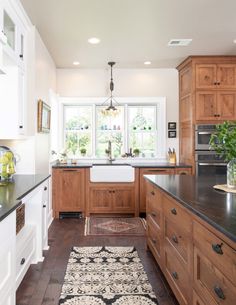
[{"xmin": 162, "ymin": 196, "xmax": 192, "ymax": 233}]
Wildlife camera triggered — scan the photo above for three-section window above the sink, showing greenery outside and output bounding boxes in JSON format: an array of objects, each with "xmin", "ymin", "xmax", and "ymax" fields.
[{"xmin": 62, "ymin": 98, "xmax": 166, "ymax": 159}]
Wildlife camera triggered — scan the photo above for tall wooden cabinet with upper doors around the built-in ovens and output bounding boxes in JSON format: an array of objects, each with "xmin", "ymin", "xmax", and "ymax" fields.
[{"xmin": 177, "ymin": 56, "xmax": 236, "ymax": 174}]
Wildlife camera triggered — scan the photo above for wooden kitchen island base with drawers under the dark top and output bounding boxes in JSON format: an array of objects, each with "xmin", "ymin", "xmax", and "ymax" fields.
[{"xmin": 146, "ymin": 182, "xmax": 236, "ymax": 305}]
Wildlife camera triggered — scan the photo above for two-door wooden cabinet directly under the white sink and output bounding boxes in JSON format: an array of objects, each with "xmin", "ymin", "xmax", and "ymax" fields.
[{"xmin": 88, "ymin": 183, "xmax": 135, "ymax": 214}]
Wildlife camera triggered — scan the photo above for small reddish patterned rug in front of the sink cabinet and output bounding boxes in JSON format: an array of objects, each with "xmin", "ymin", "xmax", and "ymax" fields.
[{"xmin": 84, "ymin": 217, "xmax": 146, "ymax": 236}]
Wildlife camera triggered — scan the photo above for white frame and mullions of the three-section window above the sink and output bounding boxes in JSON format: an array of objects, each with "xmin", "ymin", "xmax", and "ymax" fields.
[{"xmin": 59, "ymin": 97, "xmax": 166, "ymax": 161}]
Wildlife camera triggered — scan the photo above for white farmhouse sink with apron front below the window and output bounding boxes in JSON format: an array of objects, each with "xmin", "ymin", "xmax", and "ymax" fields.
[{"xmin": 90, "ymin": 165, "xmax": 135, "ymax": 182}]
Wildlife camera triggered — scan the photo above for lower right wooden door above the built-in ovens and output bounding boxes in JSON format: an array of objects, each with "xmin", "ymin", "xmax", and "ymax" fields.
[{"xmin": 217, "ymin": 91, "xmax": 236, "ymax": 121}]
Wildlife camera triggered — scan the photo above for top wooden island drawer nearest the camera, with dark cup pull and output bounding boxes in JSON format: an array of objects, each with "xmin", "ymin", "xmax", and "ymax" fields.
[{"xmin": 193, "ymin": 221, "xmax": 236, "ymax": 283}]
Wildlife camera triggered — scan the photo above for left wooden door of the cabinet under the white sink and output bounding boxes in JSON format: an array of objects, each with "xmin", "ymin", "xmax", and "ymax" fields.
[{"xmin": 89, "ymin": 186, "xmax": 113, "ymax": 213}]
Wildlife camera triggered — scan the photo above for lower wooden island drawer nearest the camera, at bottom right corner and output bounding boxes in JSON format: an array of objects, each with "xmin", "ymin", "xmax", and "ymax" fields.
[{"xmin": 194, "ymin": 247, "xmax": 236, "ymax": 305}]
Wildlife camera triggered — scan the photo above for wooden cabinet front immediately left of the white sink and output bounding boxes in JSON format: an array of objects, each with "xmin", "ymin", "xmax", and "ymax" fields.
[{"xmin": 52, "ymin": 168, "xmax": 85, "ymax": 218}]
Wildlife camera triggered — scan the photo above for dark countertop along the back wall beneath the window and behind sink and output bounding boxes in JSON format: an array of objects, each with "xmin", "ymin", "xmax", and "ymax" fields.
[{"xmin": 52, "ymin": 159, "xmax": 191, "ymax": 168}]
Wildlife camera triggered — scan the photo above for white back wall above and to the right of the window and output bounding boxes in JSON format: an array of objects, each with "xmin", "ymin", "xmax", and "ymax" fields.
[{"xmin": 57, "ymin": 68, "xmax": 179, "ymax": 159}]
